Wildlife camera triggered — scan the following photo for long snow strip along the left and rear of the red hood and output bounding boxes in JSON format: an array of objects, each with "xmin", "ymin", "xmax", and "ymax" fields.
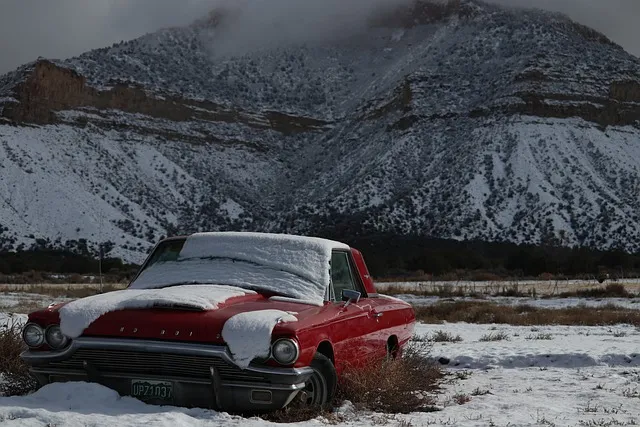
[{"xmin": 59, "ymin": 285, "xmax": 255, "ymax": 338}]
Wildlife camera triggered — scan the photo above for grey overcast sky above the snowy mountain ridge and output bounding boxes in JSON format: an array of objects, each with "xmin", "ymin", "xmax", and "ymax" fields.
[{"xmin": 0, "ymin": 0, "xmax": 640, "ymax": 73}]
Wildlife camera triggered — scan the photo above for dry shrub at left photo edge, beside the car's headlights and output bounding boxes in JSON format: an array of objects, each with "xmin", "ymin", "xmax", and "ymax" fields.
[{"xmin": 0, "ymin": 322, "xmax": 38, "ymax": 396}]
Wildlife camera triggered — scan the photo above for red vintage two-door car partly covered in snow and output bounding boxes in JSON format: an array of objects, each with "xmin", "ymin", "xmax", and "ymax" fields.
[{"xmin": 22, "ymin": 232, "xmax": 415, "ymax": 412}]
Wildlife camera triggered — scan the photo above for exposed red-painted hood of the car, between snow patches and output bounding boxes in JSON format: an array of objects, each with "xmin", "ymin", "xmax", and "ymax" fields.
[{"xmin": 41, "ymin": 293, "xmax": 326, "ymax": 344}]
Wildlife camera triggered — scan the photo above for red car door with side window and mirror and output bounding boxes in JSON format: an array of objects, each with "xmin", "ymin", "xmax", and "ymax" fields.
[{"xmin": 329, "ymin": 251, "xmax": 386, "ymax": 371}]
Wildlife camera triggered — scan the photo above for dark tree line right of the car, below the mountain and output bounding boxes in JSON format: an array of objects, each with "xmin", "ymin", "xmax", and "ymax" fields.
[{"xmin": 343, "ymin": 234, "xmax": 640, "ymax": 278}]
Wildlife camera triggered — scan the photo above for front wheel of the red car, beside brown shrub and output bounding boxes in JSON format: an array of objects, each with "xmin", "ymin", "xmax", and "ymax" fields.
[{"xmin": 298, "ymin": 353, "xmax": 338, "ymax": 407}]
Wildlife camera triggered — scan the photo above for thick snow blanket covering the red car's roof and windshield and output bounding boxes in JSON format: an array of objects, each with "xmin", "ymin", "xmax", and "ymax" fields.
[{"xmin": 131, "ymin": 232, "xmax": 349, "ymax": 304}]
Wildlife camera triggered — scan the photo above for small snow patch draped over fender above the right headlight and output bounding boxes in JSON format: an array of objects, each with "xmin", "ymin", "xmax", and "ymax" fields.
[{"xmin": 222, "ymin": 310, "xmax": 298, "ymax": 369}]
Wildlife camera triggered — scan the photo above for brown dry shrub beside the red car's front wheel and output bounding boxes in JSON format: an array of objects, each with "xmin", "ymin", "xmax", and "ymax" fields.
[{"xmin": 337, "ymin": 343, "xmax": 445, "ymax": 413}]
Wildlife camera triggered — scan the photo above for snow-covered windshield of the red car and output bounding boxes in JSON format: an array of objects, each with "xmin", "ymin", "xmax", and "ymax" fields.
[{"xmin": 130, "ymin": 238, "xmax": 324, "ymax": 300}]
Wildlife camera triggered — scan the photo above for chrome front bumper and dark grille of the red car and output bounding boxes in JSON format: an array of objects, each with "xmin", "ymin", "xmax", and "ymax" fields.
[{"xmin": 21, "ymin": 337, "xmax": 313, "ymax": 412}]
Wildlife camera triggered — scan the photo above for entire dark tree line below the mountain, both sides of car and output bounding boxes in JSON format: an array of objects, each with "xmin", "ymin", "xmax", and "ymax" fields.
[{"xmin": 0, "ymin": 234, "xmax": 640, "ymax": 278}]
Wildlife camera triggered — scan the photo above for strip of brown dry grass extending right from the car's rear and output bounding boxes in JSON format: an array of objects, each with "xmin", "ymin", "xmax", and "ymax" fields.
[{"xmin": 415, "ymin": 301, "xmax": 640, "ymax": 326}]
